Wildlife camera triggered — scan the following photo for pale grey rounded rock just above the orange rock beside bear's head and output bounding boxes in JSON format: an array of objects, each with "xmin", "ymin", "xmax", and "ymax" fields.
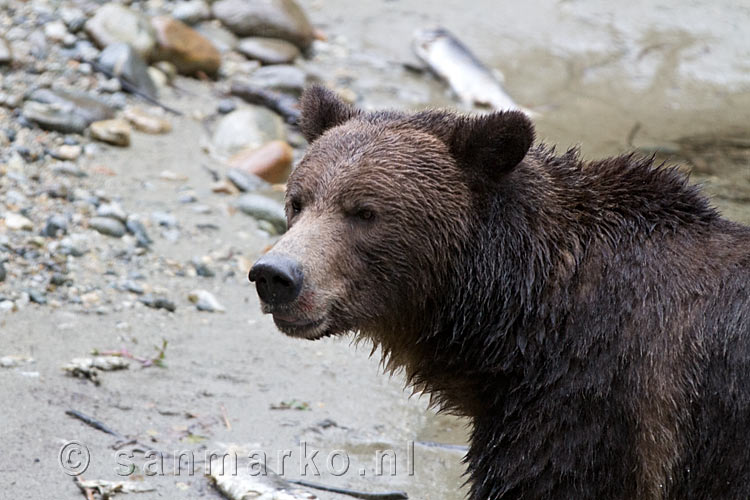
[{"xmin": 212, "ymin": 106, "xmax": 286, "ymax": 156}]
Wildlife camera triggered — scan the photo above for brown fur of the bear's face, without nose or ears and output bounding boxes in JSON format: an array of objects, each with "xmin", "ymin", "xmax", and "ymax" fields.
[{"xmin": 263, "ymin": 119, "xmax": 470, "ymax": 339}]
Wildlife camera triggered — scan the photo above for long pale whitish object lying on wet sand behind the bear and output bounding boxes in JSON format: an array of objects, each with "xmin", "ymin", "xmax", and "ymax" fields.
[{"xmin": 413, "ymin": 28, "xmax": 533, "ymax": 115}]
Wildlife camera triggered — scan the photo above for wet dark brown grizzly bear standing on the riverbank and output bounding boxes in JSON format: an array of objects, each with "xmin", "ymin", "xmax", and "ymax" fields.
[{"xmin": 249, "ymin": 87, "xmax": 750, "ymax": 500}]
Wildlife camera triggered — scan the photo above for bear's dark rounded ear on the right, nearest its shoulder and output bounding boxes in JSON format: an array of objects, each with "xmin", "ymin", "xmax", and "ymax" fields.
[{"xmin": 419, "ymin": 111, "xmax": 534, "ymax": 178}]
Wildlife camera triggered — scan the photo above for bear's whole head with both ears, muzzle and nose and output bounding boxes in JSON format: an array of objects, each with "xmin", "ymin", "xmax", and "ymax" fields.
[{"xmin": 249, "ymin": 87, "xmax": 534, "ymax": 342}]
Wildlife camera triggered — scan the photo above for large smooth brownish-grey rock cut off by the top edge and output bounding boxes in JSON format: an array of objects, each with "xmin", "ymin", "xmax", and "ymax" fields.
[{"xmin": 211, "ymin": 0, "xmax": 313, "ymax": 49}]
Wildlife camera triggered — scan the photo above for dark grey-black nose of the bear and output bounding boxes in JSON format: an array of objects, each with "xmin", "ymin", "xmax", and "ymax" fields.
[{"xmin": 247, "ymin": 254, "xmax": 302, "ymax": 306}]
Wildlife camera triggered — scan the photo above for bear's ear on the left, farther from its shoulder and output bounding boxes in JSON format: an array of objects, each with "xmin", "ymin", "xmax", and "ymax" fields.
[{"xmin": 300, "ymin": 85, "xmax": 358, "ymax": 142}]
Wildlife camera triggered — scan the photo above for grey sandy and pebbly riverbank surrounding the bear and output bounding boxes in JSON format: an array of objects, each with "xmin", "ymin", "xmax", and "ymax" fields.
[{"xmin": 0, "ymin": 0, "xmax": 750, "ymax": 499}]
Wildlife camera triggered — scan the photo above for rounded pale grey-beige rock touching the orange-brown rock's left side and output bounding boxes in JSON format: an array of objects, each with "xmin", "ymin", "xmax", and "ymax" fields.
[{"xmin": 85, "ymin": 3, "xmax": 155, "ymax": 59}]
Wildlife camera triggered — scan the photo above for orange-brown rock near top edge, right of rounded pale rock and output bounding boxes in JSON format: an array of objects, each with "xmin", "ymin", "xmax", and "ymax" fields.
[{"xmin": 151, "ymin": 16, "xmax": 221, "ymax": 75}]
